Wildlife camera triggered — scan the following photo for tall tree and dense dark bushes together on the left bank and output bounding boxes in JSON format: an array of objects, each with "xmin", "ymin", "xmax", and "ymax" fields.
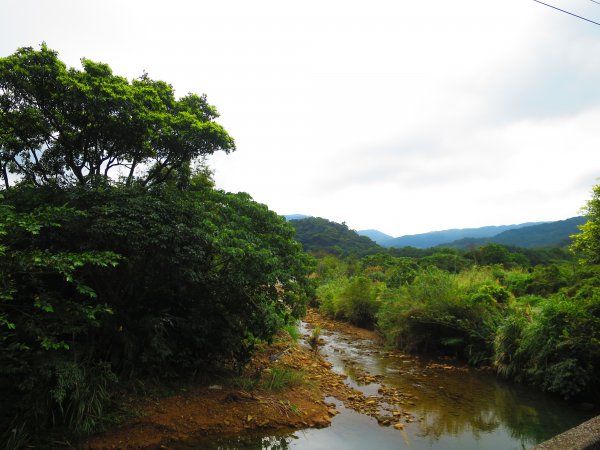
[{"xmin": 0, "ymin": 45, "xmax": 312, "ymax": 448}]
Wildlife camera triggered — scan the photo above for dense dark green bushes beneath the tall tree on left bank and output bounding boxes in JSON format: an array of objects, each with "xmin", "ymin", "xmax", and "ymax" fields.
[{"xmin": 0, "ymin": 185, "xmax": 312, "ymax": 442}]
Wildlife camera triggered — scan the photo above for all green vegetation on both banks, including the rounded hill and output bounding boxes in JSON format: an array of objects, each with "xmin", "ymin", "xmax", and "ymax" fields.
[{"xmin": 0, "ymin": 45, "xmax": 600, "ymax": 448}]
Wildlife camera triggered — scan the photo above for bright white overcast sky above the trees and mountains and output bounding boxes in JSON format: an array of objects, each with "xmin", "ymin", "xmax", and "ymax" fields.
[{"xmin": 0, "ymin": 0, "xmax": 600, "ymax": 236}]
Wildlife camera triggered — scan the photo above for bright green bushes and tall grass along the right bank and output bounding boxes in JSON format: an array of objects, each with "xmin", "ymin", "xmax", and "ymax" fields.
[{"xmin": 316, "ymin": 214, "xmax": 600, "ymax": 399}]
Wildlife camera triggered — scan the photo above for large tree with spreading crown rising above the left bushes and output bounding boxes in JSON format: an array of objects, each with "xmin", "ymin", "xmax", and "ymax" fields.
[{"xmin": 0, "ymin": 44, "xmax": 235, "ymax": 192}]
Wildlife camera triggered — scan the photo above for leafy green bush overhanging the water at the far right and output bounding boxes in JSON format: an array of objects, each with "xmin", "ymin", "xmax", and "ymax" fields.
[{"xmin": 496, "ymin": 295, "xmax": 600, "ymax": 398}]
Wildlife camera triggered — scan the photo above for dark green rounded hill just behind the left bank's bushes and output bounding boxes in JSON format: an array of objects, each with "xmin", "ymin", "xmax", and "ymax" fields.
[{"xmin": 290, "ymin": 217, "xmax": 383, "ymax": 257}]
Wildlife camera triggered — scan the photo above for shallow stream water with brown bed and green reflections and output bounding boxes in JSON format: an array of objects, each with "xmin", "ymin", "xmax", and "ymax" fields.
[{"xmin": 186, "ymin": 324, "xmax": 594, "ymax": 450}]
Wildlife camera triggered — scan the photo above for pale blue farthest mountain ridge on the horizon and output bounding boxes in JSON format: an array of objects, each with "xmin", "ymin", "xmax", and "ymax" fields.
[{"xmin": 381, "ymin": 222, "xmax": 543, "ymax": 248}]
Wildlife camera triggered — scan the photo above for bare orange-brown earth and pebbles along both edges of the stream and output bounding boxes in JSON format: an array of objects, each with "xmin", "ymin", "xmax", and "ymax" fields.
[{"xmin": 85, "ymin": 311, "xmax": 414, "ymax": 449}]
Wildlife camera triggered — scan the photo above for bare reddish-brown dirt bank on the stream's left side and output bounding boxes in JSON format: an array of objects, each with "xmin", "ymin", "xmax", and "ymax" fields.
[{"xmin": 85, "ymin": 337, "xmax": 335, "ymax": 449}]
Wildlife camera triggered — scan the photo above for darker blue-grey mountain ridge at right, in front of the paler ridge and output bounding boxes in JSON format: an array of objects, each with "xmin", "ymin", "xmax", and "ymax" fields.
[{"xmin": 442, "ymin": 217, "xmax": 586, "ymax": 249}]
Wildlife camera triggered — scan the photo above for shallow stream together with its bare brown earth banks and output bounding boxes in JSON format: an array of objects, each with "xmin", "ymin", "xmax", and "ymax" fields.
[{"xmin": 87, "ymin": 311, "xmax": 590, "ymax": 450}]
